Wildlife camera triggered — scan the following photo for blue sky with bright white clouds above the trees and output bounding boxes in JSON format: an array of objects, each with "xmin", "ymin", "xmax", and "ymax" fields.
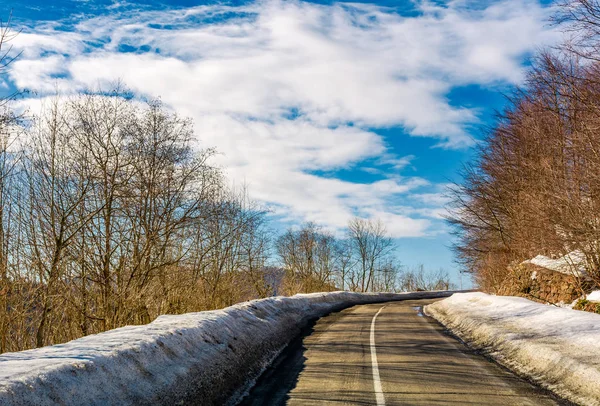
[{"xmin": 0, "ymin": 0, "xmax": 557, "ymax": 281}]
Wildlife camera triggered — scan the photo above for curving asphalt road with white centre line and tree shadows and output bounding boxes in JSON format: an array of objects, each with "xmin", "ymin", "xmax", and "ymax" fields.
[{"xmin": 241, "ymin": 299, "xmax": 569, "ymax": 406}]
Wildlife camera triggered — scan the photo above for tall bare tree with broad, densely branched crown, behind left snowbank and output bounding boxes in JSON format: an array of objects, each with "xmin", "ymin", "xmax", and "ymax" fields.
[{"xmin": 117, "ymin": 97, "xmax": 218, "ymax": 323}]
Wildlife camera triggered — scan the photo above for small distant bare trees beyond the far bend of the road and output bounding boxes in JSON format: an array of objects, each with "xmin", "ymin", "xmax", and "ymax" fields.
[{"xmin": 275, "ymin": 218, "xmax": 454, "ymax": 294}]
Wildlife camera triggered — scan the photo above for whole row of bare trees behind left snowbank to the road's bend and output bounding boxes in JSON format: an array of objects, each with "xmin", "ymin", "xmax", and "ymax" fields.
[{"xmin": 0, "ymin": 17, "xmax": 449, "ymax": 353}]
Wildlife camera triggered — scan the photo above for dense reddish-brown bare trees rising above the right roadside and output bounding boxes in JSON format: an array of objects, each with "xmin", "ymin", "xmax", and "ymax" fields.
[{"xmin": 450, "ymin": 0, "xmax": 600, "ymax": 291}]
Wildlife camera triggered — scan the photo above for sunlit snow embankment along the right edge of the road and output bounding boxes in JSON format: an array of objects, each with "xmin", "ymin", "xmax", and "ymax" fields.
[{"xmin": 425, "ymin": 293, "xmax": 600, "ymax": 406}]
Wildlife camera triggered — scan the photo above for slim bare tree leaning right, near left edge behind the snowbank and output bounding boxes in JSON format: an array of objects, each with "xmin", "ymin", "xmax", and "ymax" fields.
[{"xmin": 25, "ymin": 99, "xmax": 102, "ymax": 347}]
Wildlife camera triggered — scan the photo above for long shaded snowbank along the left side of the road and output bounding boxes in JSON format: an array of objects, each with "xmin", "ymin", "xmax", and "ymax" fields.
[{"xmin": 0, "ymin": 292, "xmax": 449, "ymax": 405}]
